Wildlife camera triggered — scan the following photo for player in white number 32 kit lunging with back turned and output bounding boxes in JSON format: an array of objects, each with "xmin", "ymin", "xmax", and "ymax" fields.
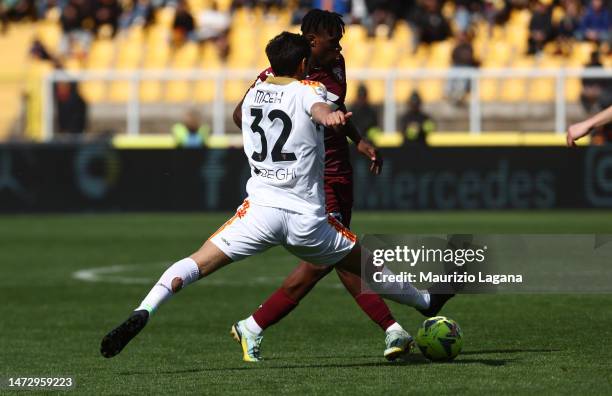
[{"xmin": 100, "ymin": 32, "xmax": 430, "ymax": 357}]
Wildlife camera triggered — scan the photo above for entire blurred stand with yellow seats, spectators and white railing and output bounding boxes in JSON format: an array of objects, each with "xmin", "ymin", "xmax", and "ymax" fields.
[{"xmin": 0, "ymin": 0, "xmax": 612, "ymax": 148}]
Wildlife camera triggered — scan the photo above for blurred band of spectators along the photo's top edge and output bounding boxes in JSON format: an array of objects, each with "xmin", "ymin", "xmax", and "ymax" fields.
[{"xmin": 0, "ymin": 0, "xmax": 612, "ymax": 48}]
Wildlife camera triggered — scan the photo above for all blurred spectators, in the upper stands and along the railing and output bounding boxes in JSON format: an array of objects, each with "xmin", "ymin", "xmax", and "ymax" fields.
[{"xmin": 0, "ymin": 0, "xmax": 612, "ymax": 139}]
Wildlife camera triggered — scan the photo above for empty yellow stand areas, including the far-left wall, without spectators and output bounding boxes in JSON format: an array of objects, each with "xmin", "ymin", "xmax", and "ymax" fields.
[{"xmin": 0, "ymin": 0, "xmax": 612, "ymax": 140}]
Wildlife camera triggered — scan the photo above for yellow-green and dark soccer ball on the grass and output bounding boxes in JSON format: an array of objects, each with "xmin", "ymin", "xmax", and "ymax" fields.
[{"xmin": 416, "ymin": 316, "xmax": 463, "ymax": 362}]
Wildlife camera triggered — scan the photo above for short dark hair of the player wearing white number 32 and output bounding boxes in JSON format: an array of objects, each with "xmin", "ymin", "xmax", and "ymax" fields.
[{"xmin": 266, "ymin": 32, "xmax": 310, "ymax": 77}]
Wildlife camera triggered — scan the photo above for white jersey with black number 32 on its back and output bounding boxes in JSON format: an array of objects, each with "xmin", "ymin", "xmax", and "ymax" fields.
[{"xmin": 242, "ymin": 77, "xmax": 326, "ymax": 215}]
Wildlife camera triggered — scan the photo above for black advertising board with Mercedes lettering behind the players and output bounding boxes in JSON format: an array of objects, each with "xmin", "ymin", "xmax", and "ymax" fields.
[{"xmin": 0, "ymin": 144, "xmax": 612, "ymax": 212}]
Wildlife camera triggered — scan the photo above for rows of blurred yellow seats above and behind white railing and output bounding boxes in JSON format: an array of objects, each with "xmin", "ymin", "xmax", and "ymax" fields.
[{"xmin": 0, "ymin": 0, "xmax": 612, "ymax": 116}]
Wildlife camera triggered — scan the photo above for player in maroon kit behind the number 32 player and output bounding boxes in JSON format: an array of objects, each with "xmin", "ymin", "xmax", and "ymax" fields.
[{"xmin": 232, "ymin": 9, "xmax": 413, "ymax": 361}]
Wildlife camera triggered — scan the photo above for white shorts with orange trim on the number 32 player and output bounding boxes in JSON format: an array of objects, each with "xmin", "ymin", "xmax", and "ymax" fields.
[{"xmin": 210, "ymin": 199, "xmax": 357, "ymax": 265}]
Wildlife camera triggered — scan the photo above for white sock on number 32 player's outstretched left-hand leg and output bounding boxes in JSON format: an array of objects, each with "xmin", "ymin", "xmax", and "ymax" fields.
[{"xmin": 136, "ymin": 257, "xmax": 200, "ymax": 314}]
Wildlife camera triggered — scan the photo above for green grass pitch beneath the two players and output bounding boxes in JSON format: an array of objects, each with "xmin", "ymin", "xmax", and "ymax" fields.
[{"xmin": 0, "ymin": 211, "xmax": 612, "ymax": 395}]
